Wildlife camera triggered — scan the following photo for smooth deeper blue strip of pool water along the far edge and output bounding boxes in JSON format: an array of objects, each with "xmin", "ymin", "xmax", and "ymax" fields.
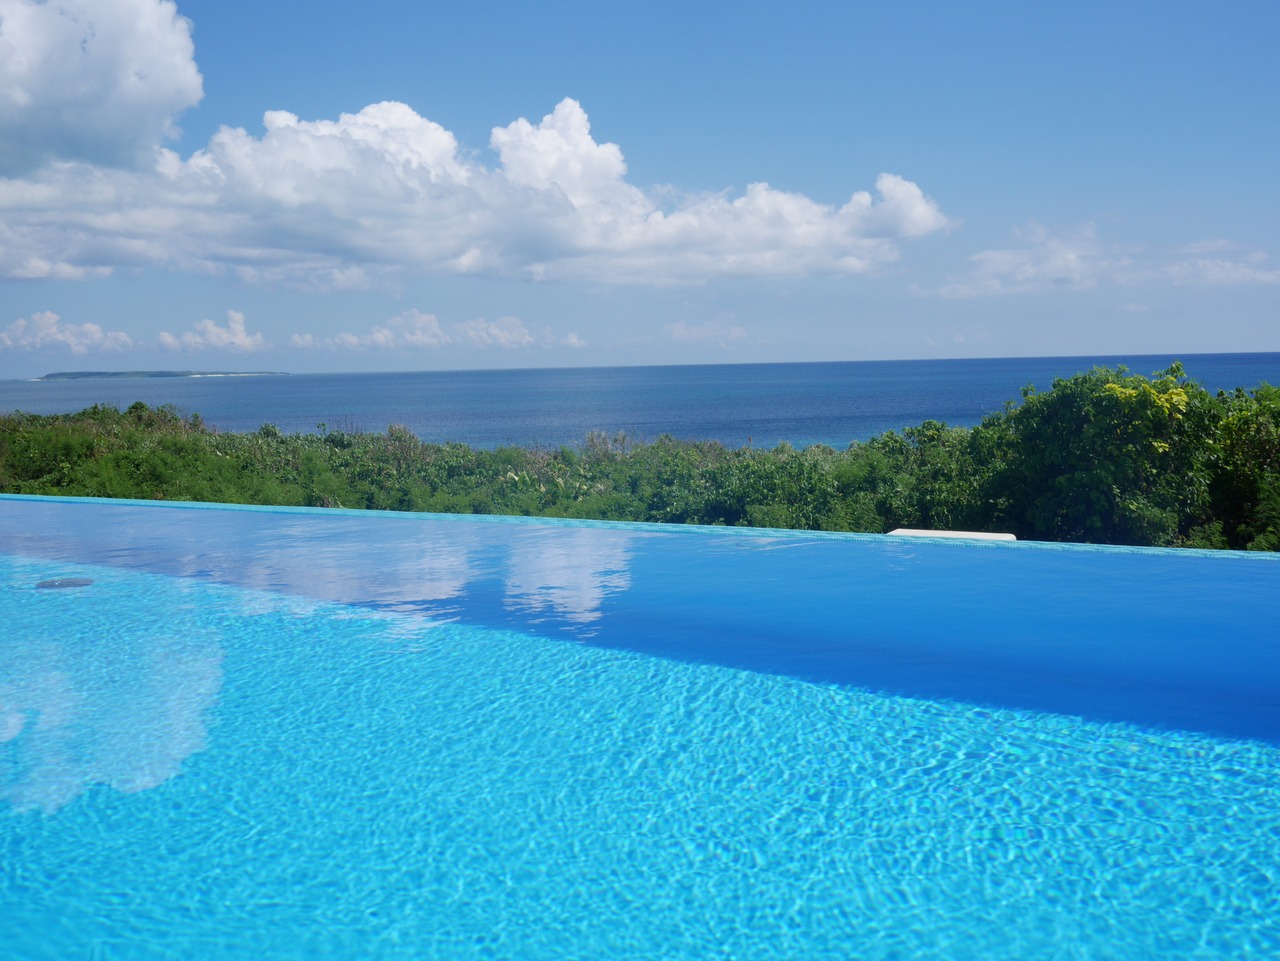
[{"xmin": 0, "ymin": 496, "xmax": 1280, "ymax": 742}]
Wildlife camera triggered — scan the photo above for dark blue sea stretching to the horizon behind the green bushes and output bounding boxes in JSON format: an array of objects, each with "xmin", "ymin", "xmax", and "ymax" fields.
[{"xmin": 0, "ymin": 353, "xmax": 1280, "ymax": 448}]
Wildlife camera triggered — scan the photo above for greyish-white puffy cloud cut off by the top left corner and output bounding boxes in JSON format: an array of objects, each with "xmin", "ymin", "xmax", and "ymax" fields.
[{"xmin": 0, "ymin": 0, "xmax": 204, "ymax": 175}]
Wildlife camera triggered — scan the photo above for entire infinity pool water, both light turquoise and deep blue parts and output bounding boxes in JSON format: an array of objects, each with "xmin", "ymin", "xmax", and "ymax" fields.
[{"xmin": 0, "ymin": 498, "xmax": 1280, "ymax": 958}]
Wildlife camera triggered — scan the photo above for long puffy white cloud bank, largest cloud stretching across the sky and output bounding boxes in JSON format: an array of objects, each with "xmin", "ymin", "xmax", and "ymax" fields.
[{"xmin": 0, "ymin": 63, "xmax": 947, "ymax": 289}]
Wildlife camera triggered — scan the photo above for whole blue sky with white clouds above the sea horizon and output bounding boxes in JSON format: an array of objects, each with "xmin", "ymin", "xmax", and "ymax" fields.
[{"xmin": 0, "ymin": 0, "xmax": 1280, "ymax": 377}]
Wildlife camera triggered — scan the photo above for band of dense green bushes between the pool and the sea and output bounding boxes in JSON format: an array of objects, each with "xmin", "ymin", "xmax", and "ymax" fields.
[{"xmin": 0, "ymin": 365, "xmax": 1280, "ymax": 550}]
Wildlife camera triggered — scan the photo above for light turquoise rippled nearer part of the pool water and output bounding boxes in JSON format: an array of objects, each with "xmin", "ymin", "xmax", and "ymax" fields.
[{"xmin": 0, "ymin": 558, "xmax": 1280, "ymax": 961}]
